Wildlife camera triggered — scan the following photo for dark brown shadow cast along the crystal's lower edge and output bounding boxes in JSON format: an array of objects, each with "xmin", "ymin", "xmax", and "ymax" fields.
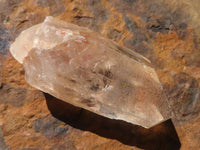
[{"xmin": 44, "ymin": 93, "xmax": 181, "ymax": 150}]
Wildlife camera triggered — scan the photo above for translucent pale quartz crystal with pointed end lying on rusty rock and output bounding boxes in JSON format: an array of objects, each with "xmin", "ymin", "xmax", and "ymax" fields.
[{"xmin": 10, "ymin": 16, "xmax": 170, "ymax": 128}]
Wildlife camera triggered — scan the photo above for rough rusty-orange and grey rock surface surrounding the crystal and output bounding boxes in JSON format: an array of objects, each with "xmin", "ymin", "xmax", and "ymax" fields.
[{"xmin": 0, "ymin": 0, "xmax": 200, "ymax": 150}]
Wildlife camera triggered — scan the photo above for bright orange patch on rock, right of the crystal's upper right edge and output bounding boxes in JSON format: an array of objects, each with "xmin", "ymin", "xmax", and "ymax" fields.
[{"xmin": 153, "ymin": 31, "xmax": 194, "ymax": 82}]
